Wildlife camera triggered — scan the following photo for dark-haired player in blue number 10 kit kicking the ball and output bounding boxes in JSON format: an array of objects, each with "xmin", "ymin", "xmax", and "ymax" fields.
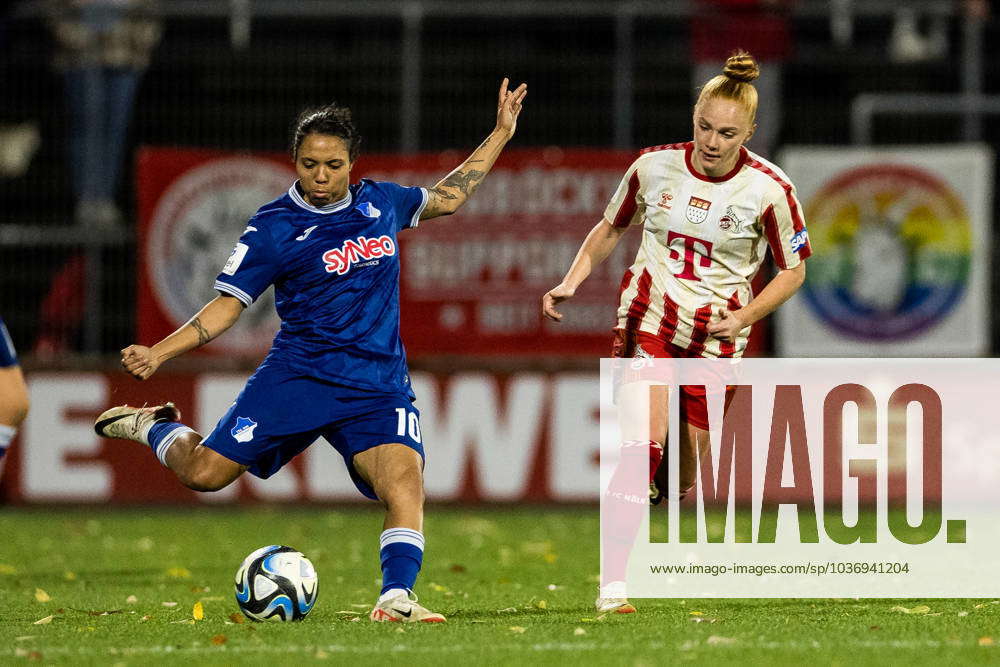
[{"xmin": 94, "ymin": 79, "xmax": 527, "ymax": 623}]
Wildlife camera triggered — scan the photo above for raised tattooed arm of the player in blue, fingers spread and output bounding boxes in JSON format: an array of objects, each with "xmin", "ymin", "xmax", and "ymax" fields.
[{"xmin": 420, "ymin": 78, "xmax": 528, "ymax": 220}]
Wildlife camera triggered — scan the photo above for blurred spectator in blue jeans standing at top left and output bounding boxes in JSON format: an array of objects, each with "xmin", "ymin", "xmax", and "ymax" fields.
[{"xmin": 50, "ymin": 0, "xmax": 161, "ymax": 229}]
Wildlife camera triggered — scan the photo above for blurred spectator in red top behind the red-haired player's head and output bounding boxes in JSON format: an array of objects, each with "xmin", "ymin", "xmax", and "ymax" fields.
[{"xmin": 691, "ymin": 0, "xmax": 795, "ymax": 157}]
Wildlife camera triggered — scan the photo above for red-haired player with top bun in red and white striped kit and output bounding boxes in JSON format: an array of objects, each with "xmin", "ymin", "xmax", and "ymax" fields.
[{"xmin": 542, "ymin": 51, "xmax": 811, "ymax": 613}]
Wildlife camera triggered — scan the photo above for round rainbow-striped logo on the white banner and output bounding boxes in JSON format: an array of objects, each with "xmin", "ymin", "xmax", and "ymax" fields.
[{"xmin": 803, "ymin": 165, "xmax": 972, "ymax": 341}]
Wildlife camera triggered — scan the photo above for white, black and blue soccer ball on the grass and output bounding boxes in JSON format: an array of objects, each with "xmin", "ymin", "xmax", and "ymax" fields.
[{"xmin": 236, "ymin": 545, "xmax": 319, "ymax": 621}]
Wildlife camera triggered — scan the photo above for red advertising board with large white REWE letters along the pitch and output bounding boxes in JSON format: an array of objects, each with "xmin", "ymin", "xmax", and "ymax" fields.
[{"xmin": 0, "ymin": 370, "xmax": 928, "ymax": 506}]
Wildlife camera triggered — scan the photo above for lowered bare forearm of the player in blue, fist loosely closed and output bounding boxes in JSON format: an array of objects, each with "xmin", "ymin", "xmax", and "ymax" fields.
[{"xmin": 122, "ymin": 296, "xmax": 243, "ymax": 380}]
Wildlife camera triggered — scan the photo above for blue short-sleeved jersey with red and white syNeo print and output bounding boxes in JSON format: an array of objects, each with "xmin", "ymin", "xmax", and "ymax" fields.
[{"xmin": 215, "ymin": 179, "xmax": 427, "ymax": 395}]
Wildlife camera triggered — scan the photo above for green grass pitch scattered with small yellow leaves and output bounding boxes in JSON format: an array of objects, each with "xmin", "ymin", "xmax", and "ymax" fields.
[{"xmin": 0, "ymin": 505, "xmax": 1000, "ymax": 667}]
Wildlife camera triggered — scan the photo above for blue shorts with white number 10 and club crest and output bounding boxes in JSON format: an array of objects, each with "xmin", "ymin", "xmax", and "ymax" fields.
[{"xmin": 202, "ymin": 361, "xmax": 424, "ymax": 500}]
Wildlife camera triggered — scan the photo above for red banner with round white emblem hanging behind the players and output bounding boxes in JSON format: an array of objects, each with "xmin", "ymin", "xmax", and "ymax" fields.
[{"xmin": 137, "ymin": 147, "xmax": 765, "ymax": 358}]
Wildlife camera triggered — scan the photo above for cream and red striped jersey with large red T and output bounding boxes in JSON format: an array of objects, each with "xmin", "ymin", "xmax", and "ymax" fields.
[{"xmin": 604, "ymin": 142, "xmax": 811, "ymax": 357}]
